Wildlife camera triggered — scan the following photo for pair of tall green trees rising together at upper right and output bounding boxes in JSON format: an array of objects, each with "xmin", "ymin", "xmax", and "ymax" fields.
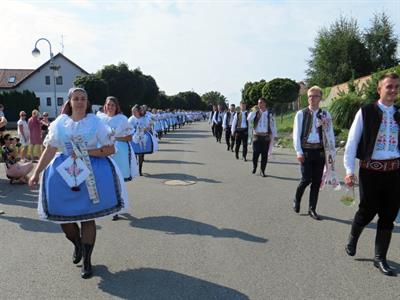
[{"xmin": 306, "ymin": 13, "xmax": 399, "ymax": 87}]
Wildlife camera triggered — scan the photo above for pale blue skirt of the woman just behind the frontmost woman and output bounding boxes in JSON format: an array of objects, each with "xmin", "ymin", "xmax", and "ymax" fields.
[{"xmin": 112, "ymin": 141, "xmax": 139, "ymax": 181}]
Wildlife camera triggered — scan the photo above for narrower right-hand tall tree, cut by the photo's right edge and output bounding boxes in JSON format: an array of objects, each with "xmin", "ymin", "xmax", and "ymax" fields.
[{"xmin": 364, "ymin": 12, "xmax": 399, "ymax": 71}]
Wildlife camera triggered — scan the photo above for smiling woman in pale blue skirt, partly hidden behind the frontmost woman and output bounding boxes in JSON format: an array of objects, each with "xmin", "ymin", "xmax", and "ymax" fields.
[{"xmin": 97, "ymin": 96, "xmax": 139, "ymax": 181}]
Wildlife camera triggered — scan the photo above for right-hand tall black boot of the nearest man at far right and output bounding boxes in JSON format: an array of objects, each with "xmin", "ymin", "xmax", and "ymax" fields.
[{"xmin": 374, "ymin": 229, "xmax": 396, "ymax": 276}]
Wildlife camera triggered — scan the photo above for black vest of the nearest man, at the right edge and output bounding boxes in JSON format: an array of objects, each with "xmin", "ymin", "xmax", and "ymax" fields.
[{"xmin": 356, "ymin": 102, "xmax": 400, "ymax": 161}]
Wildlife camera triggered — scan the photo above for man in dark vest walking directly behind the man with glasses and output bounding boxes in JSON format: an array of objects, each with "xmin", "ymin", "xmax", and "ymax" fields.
[{"xmin": 247, "ymin": 98, "xmax": 276, "ymax": 177}]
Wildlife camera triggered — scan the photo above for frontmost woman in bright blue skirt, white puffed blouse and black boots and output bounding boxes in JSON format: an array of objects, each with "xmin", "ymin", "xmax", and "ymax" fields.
[{"xmin": 29, "ymin": 88, "xmax": 128, "ymax": 278}]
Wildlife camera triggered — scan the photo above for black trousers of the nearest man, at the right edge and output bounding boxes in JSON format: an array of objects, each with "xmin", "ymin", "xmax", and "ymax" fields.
[{"xmin": 353, "ymin": 168, "xmax": 400, "ymax": 231}]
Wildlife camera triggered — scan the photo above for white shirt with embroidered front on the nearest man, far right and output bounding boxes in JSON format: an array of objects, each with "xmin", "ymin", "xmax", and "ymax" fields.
[{"xmin": 343, "ymin": 100, "xmax": 400, "ymax": 174}]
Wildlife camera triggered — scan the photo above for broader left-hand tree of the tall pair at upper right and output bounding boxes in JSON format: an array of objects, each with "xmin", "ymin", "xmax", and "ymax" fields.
[{"xmin": 306, "ymin": 16, "xmax": 372, "ymax": 86}]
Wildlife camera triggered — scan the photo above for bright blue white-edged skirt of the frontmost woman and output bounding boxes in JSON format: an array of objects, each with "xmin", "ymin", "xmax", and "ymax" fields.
[{"xmin": 38, "ymin": 154, "xmax": 127, "ymax": 223}]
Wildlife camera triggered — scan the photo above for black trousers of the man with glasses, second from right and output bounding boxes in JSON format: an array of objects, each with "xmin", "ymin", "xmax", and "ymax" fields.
[{"xmin": 295, "ymin": 149, "xmax": 325, "ymax": 210}]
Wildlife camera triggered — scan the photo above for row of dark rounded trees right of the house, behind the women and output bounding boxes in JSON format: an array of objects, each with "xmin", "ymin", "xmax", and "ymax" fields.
[{"xmin": 74, "ymin": 63, "xmax": 227, "ymax": 114}]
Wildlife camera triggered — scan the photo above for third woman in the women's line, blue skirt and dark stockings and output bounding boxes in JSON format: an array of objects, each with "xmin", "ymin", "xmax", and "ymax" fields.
[{"xmin": 128, "ymin": 105, "xmax": 154, "ymax": 176}]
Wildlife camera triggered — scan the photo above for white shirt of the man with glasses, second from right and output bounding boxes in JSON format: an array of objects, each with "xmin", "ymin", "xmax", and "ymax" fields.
[{"xmin": 293, "ymin": 108, "xmax": 333, "ymax": 156}]
